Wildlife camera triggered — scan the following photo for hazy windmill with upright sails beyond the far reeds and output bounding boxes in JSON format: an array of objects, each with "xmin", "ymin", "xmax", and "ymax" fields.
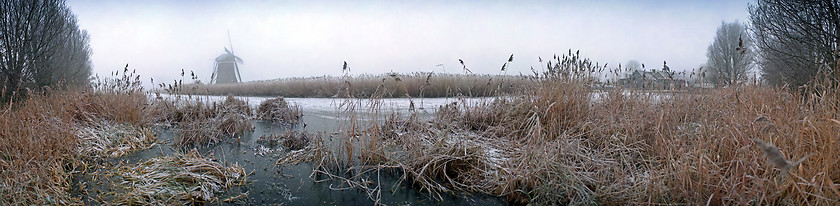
[{"xmin": 210, "ymin": 31, "xmax": 242, "ymax": 84}]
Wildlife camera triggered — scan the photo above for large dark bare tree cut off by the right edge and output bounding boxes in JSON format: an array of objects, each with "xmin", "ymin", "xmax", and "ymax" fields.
[{"xmin": 749, "ymin": 0, "xmax": 840, "ymax": 87}]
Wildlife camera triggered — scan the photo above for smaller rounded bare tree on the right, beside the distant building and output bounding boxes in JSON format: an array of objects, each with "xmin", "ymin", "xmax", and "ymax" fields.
[{"xmin": 706, "ymin": 21, "xmax": 755, "ymax": 86}]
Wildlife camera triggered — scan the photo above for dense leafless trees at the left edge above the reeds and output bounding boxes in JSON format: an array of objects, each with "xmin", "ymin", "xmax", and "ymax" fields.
[{"xmin": 0, "ymin": 0, "xmax": 91, "ymax": 96}]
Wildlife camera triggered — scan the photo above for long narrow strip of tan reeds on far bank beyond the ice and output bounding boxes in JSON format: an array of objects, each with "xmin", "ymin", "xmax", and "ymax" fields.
[{"xmin": 169, "ymin": 72, "xmax": 536, "ymax": 98}]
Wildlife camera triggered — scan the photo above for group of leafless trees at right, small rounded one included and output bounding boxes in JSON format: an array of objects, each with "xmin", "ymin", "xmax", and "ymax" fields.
[{"xmin": 704, "ymin": 0, "xmax": 840, "ymax": 88}]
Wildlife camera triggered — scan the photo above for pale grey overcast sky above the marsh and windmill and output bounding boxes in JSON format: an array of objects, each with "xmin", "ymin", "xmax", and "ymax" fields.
[{"xmin": 68, "ymin": 0, "xmax": 750, "ymax": 86}]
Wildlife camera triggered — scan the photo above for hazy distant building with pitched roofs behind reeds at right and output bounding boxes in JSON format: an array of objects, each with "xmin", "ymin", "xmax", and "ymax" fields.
[{"xmin": 619, "ymin": 70, "xmax": 688, "ymax": 90}]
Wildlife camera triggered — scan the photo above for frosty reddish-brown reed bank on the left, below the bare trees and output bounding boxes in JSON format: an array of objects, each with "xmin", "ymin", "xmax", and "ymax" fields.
[{"xmin": 0, "ymin": 68, "xmax": 152, "ymax": 205}]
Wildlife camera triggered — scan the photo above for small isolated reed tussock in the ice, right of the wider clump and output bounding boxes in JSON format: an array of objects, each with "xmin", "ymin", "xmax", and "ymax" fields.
[{"xmin": 257, "ymin": 97, "xmax": 303, "ymax": 125}]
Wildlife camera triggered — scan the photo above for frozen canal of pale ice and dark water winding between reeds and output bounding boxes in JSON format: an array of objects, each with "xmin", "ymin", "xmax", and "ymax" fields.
[{"xmin": 88, "ymin": 96, "xmax": 504, "ymax": 205}]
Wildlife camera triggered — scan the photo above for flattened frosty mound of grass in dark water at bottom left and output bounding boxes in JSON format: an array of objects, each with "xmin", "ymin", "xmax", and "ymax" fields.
[{"xmin": 109, "ymin": 149, "xmax": 247, "ymax": 205}]
